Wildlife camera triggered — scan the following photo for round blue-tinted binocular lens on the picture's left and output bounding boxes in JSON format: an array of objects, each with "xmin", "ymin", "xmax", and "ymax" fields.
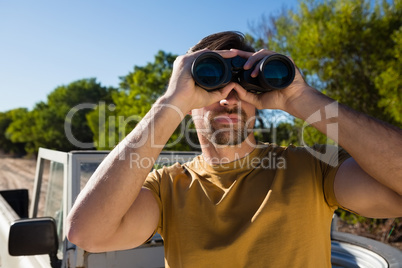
[{"xmin": 195, "ymin": 57, "xmax": 225, "ymax": 85}]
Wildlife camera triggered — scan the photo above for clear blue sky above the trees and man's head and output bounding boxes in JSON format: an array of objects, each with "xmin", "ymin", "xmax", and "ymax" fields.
[{"xmin": 0, "ymin": 0, "xmax": 298, "ymax": 112}]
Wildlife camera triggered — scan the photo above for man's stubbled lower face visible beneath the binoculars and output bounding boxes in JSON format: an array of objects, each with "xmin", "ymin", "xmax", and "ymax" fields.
[{"xmin": 192, "ymin": 90, "xmax": 255, "ymax": 145}]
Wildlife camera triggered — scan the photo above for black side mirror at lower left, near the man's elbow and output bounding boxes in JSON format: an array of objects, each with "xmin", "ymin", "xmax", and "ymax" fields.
[{"xmin": 8, "ymin": 217, "xmax": 59, "ymax": 256}]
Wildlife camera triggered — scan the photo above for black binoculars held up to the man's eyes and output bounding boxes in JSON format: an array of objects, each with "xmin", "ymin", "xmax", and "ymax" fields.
[{"xmin": 191, "ymin": 52, "xmax": 295, "ymax": 93}]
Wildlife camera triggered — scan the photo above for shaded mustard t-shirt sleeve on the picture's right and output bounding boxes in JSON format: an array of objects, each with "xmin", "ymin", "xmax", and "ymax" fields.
[{"xmin": 312, "ymin": 145, "xmax": 350, "ymax": 209}]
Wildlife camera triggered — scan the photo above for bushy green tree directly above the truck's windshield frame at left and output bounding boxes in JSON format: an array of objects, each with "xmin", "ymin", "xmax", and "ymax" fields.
[{"xmin": 6, "ymin": 78, "xmax": 115, "ymax": 153}]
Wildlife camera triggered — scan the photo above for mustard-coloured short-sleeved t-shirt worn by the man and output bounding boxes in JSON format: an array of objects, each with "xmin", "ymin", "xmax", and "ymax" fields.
[{"xmin": 144, "ymin": 144, "xmax": 347, "ymax": 268}]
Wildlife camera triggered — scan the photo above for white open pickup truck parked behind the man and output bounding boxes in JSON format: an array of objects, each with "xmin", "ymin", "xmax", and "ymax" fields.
[{"xmin": 0, "ymin": 148, "xmax": 402, "ymax": 268}]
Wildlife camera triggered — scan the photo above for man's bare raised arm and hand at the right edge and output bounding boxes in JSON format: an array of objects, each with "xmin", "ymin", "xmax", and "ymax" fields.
[{"xmin": 235, "ymin": 50, "xmax": 402, "ymax": 218}]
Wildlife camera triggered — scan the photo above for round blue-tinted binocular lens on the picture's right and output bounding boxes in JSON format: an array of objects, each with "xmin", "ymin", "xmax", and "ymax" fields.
[{"xmin": 263, "ymin": 60, "xmax": 291, "ymax": 87}]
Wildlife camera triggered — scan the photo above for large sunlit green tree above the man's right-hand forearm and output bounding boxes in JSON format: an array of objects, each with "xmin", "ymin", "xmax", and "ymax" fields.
[{"xmin": 248, "ymin": 0, "xmax": 402, "ymax": 127}]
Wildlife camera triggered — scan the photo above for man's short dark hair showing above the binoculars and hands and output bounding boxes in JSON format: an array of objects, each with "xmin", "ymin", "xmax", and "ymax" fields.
[{"xmin": 187, "ymin": 31, "xmax": 255, "ymax": 53}]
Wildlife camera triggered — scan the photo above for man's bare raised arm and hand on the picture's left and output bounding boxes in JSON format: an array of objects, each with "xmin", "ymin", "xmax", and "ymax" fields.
[{"xmin": 66, "ymin": 51, "xmax": 236, "ymax": 252}]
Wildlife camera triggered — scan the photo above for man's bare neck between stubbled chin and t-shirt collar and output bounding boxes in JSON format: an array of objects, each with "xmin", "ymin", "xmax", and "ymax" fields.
[{"xmin": 202, "ymin": 134, "xmax": 256, "ymax": 165}]
